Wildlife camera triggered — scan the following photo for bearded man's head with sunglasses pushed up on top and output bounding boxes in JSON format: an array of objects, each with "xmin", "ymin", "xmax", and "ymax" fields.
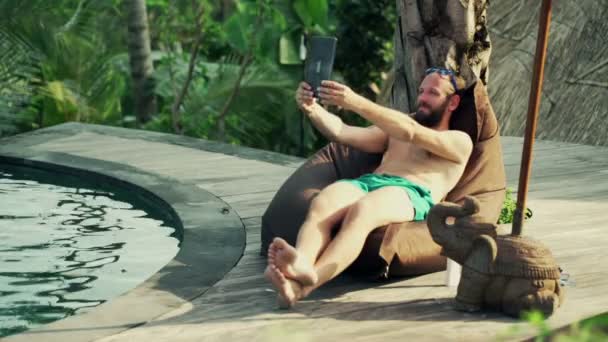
[{"xmin": 414, "ymin": 68, "xmax": 464, "ymax": 128}]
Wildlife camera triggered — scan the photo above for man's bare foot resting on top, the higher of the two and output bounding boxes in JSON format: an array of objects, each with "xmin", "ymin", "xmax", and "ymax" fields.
[{"xmin": 268, "ymin": 237, "xmax": 318, "ymax": 286}]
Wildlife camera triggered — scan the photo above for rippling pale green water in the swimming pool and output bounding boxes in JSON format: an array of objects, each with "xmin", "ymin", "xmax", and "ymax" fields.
[{"xmin": 0, "ymin": 164, "xmax": 179, "ymax": 337}]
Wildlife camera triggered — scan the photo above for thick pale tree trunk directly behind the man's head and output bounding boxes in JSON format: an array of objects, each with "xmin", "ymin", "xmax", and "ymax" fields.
[{"xmin": 390, "ymin": 0, "xmax": 491, "ymax": 113}]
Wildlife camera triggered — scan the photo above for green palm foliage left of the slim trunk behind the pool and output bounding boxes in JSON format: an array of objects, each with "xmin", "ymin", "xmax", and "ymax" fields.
[{"xmin": 0, "ymin": 0, "xmax": 128, "ymax": 134}]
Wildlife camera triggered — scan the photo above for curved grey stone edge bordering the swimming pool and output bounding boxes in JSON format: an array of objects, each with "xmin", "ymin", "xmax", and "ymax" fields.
[{"xmin": 0, "ymin": 152, "xmax": 245, "ymax": 341}]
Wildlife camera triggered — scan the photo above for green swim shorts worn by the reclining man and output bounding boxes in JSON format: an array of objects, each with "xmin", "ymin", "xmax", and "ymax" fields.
[{"xmin": 340, "ymin": 173, "xmax": 434, "ymax": 221}]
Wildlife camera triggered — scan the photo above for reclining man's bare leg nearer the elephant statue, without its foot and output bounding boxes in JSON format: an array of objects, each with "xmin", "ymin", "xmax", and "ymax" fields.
[{"xmin": 312, "ymin": 186, "xmax": 414, "ymax": 293}]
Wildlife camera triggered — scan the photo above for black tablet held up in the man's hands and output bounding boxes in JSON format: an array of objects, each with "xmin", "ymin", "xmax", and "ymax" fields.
[{"xmin": 304, "ymin": 36, "xmax": 338, "ymax": 97}]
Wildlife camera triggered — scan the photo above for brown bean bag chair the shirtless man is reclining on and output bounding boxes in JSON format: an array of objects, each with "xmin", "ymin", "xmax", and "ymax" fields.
[{"xmin": 260, "ymin": 82, "xmax": 506, "ymax": 277}]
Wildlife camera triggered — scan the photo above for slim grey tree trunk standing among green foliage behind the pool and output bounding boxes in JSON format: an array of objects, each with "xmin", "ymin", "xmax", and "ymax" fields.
[{"xmin": 125, "ymin": 0, "xmax": 156, "ymax": 125}]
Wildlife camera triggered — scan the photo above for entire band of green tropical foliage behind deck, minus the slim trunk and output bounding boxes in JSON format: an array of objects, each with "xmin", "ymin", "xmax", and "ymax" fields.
[{"xmin": 0, "ymin": 0, "xmax": 395, "ymax": 155}]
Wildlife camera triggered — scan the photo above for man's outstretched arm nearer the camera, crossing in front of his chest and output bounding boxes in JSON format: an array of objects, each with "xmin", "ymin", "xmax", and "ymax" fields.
[{"xmin": 322, "ymin": 81, "xmax": 473, "ymax": 163}]
